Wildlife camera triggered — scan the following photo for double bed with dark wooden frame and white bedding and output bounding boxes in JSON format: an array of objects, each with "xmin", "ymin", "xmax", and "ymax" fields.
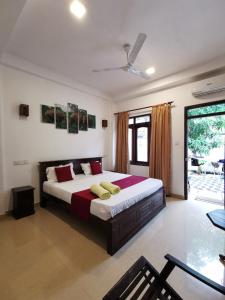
[{"xmin": 39, "ymin": 157, "xmax": 166, "ymax": 255}]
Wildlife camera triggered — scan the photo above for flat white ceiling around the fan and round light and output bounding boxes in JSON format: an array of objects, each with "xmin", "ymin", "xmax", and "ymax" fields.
[{"xmin": 0, "ymin": 0, "xmax": 225, "ymax": 96}]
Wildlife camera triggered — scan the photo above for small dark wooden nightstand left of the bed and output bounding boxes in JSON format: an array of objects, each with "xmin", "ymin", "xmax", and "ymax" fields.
[{"xmin": 12, "ymin": 186, "xmax": 35, "ymax": 219}]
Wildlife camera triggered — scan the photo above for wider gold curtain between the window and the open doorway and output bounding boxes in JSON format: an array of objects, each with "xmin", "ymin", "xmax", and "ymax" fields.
[{"xmin": 149, "ymin": 104, "xmax": 171, "ymax": 195}]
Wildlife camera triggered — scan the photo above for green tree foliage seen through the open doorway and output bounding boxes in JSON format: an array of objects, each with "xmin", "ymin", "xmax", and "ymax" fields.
[{"xmin": 188, "ymin": 104, "xmax": 225, "ymax": 156}]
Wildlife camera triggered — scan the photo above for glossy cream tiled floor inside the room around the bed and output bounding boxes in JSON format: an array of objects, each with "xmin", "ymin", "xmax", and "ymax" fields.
[{"xmin": 0, "ymin": 199, "xmax": 225, "ymax": 300}]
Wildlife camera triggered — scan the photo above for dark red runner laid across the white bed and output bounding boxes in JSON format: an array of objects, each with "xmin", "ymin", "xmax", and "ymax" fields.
[{"xmin": 71, "ymin": 176, "xmax": 147, "ymax": 220}]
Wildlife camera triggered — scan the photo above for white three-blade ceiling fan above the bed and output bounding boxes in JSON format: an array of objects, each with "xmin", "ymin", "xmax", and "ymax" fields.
[{"xmin": 92, "ymin": 33, "xmax": 149, "ymax": 79}]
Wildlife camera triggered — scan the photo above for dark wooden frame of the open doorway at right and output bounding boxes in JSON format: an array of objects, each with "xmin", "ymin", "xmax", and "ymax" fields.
[{"xmin": 184, "ymin": 99, "xmax": 225, "ymax": 200}]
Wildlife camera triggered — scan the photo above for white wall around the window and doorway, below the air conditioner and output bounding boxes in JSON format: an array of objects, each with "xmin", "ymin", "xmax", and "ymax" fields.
[{"xmin": 116, "ymin": 75, "xmax": 225, "ymax": 195}]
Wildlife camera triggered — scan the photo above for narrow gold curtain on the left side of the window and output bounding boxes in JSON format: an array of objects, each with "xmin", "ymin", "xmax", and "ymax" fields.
[{"xmin": 115, "ymin": 112, "xmax": 128, "ymax": 173}]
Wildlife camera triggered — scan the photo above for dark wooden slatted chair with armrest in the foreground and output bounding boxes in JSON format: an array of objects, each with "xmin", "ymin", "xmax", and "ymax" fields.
[{"xmin": 103, "ymin": 254, "xmax": 225, "ymax": 300}]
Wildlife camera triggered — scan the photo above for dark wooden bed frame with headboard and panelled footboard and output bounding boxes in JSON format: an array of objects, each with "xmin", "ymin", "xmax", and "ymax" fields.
[{"xmin": 39, "ymin": 157, "xmax": 166, "ymax": 255}]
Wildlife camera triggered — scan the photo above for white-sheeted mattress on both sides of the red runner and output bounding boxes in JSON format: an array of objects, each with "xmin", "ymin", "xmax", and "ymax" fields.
[{"xmin": 43, "ymin": 171, "xmax": 163, "ymax": 221}]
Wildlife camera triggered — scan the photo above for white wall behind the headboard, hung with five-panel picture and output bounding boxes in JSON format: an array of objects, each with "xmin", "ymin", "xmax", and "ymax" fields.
[{"xmin": 0, "ymin": 66, "xmax": 112, "ymax": 213}]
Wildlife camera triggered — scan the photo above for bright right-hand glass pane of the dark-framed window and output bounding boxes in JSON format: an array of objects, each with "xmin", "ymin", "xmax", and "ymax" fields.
[{"xmin": 137, "ymin": 127, "xmax": 148, "ymax": 162}]
